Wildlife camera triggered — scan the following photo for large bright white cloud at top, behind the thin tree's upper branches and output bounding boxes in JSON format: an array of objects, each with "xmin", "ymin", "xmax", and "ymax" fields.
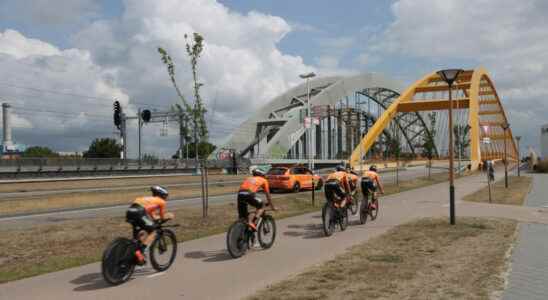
[{"xmin": 73, "ymin": 0, "xmax": 323, "ymax": 155}]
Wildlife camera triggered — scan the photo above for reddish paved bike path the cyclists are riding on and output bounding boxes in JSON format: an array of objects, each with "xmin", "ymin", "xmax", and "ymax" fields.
[{"xmin": 0, "ymin": 172, "xmax": 548, "ymax": 300}]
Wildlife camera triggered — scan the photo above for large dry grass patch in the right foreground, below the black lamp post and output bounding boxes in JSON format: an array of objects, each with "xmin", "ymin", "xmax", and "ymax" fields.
[{"xmin": 250, "ymin": 218, "xmax": 517, "ymax": 299}]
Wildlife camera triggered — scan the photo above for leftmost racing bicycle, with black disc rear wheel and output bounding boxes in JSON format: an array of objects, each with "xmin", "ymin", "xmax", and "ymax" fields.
[{"xmin": 101, "ymin": 220, "xmax": 179, "ymax": 285}]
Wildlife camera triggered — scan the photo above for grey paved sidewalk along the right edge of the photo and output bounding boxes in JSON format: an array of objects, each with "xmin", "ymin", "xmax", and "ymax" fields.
[{"xmin": 503, "ymin": 174, "xmax": 548, "ymax": 300}]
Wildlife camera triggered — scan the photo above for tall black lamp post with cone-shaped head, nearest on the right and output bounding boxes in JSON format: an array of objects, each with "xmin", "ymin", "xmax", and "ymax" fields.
[{"xmin": 437, "ymin": 69, "xmax": 463, "ymax": 225}]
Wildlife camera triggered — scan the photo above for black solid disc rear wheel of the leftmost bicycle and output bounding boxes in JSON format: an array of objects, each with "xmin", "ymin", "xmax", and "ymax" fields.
[{"xmin": 101, "ymin": 238, "xmax": 137, "ymax": 285}]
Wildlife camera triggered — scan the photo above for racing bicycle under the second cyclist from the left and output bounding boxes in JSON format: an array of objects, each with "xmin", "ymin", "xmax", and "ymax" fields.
[{"xmin": 226, "ymin": 211, "xmax": 276, "ymax": 258}]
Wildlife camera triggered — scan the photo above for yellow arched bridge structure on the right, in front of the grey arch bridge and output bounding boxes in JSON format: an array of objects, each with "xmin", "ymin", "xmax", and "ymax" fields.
[{"xmin": 350, "ymin": 67, "xmax": 517, "ymax": 169}]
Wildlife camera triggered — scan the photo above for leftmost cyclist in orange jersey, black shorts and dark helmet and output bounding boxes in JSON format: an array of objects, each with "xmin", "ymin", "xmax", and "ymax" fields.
[{"xmin": 126, "ymin": 186, "xmax": 174, "ymax": 265}]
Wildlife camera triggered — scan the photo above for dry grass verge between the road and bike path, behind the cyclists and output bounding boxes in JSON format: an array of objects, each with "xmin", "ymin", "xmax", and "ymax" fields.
[{"xmin": 0, "ymin": 193, "xmax": 321, "ymax": 283}]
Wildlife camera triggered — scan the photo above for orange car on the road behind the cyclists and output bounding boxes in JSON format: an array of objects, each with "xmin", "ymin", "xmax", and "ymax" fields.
[{"xmin": 266, "ymin": 166, "xmax": 323, "ymax": 192}]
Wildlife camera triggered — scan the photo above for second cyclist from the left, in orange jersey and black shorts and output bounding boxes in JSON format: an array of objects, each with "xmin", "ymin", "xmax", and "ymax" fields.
[{"xmin": 238, "ymin": 169, "xmax": 277, "ymax": 230}]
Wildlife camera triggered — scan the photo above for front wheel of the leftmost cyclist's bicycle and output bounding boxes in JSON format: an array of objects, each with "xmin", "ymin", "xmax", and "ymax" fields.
[{"xmin": 149, "ymin": 229, "xmax": 177, "ymax": 272}]
